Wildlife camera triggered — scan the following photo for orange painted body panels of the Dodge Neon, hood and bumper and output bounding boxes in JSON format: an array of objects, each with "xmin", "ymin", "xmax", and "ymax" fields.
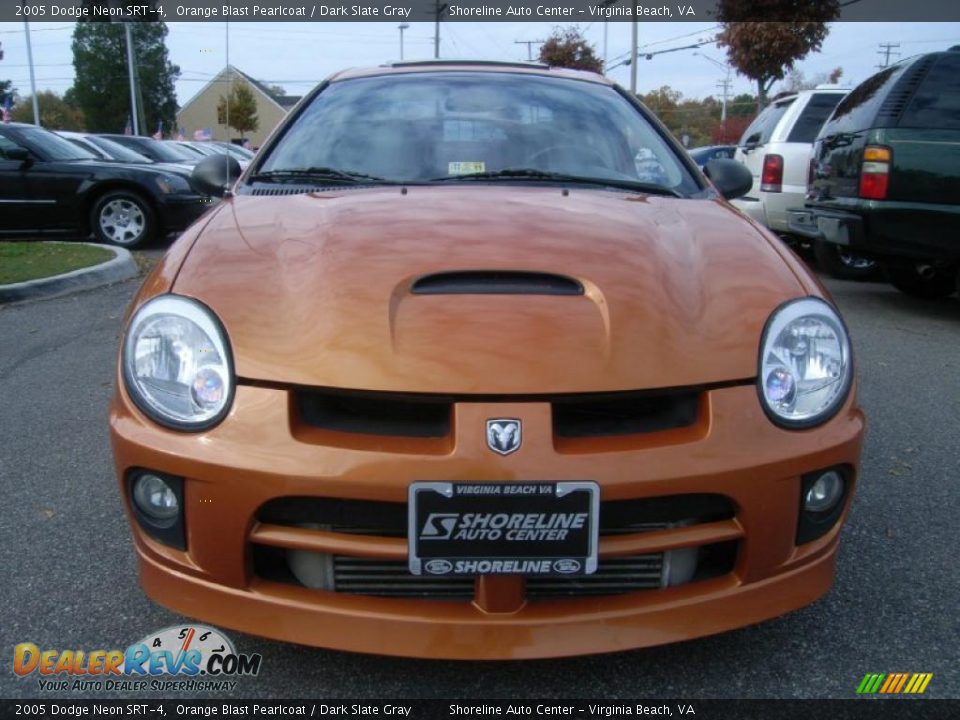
[{"xmin": 110, "ymin": 64, "xmax": 864, "ymax": 659}]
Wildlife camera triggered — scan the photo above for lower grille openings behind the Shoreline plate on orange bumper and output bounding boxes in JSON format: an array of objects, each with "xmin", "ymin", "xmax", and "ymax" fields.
[{"xmin": 252, "ymin": 494, "xmax": 737, "ymax": 601}]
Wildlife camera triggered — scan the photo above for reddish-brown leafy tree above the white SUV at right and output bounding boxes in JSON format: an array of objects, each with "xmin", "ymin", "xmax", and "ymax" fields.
[{"xmin": 717, "ymin": 0, "xmax": 840, "ymax": 107}]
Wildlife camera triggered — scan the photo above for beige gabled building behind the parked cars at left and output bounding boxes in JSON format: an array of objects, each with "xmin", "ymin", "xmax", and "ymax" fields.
[{"xmin": 177, "ymin": 65, "xmax": 300, "ymax": 147}]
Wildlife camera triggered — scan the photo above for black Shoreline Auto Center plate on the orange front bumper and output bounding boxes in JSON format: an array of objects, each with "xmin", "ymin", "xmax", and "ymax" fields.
[{"xmin": 408, "ymin": 481, "xmax": 600, "ymax": 575}]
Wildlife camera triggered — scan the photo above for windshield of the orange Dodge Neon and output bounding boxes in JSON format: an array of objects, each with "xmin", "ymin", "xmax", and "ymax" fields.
[{"xmin": 252, "ymin": 72, "xmax": 700, "ymax": 194}]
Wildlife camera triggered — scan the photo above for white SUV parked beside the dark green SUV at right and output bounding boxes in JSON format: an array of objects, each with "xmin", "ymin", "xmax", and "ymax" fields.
[{"xmin": 734, "ymin": 85, "xmax": 876, "ymax": 278}]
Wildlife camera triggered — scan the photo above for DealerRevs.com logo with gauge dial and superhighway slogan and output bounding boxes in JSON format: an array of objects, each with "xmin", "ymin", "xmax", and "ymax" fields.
[{"xmin": 13, "ymin": 625, "xmax": 263, "ymax": 692}]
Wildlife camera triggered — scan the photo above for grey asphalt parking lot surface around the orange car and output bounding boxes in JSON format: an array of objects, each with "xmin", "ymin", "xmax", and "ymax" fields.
[{"xmin": 0, "ymin": 268, "xmax": 960, "ymax": 699}]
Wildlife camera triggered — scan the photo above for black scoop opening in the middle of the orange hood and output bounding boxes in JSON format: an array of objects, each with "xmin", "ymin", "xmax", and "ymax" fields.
[{"xmin": 410, "ymin": 270, "xmax": 583, "ymax": 295}]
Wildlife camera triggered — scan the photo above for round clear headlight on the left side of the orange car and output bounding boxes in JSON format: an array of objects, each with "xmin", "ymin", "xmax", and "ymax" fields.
[{"xmin": 122, "ymin": 295, "xmax": 233, "ymax": 430}]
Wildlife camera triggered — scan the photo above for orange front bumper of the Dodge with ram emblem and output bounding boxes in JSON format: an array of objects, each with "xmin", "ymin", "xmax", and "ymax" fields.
[{"xmin": 110, "ymin": 385, "xmax": 864, "ymax": 659}]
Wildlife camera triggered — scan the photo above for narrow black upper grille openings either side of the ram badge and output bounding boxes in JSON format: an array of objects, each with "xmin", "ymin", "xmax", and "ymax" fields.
[{"xmin": 293, "ymin": 388, "xmax": 703, "ymax": 438}]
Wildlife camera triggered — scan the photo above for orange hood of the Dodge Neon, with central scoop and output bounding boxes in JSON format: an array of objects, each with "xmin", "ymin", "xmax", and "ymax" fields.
[{"xmin": 173, "ymin": 185, "xmax": 809, "ymax": 394}]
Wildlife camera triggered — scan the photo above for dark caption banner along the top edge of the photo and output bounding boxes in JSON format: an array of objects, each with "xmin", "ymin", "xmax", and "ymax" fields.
[{"xmin": 0, "ymin": 0, "xmax": 960, "ymax": 23}]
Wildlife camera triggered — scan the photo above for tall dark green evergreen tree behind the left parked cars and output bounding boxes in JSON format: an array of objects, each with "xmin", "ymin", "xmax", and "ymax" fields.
[{"xmin": 68, "ymin": 17, "xmax": 180, "ymax": 135}]
